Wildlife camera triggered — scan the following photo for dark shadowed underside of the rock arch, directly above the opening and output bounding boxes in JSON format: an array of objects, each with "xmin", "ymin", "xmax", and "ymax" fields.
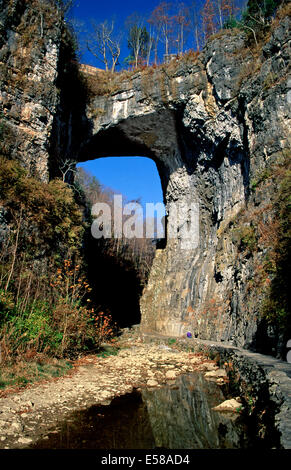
[{"xmin": 79, "ymin": 109, "xmax": 187, "ymax": 207}]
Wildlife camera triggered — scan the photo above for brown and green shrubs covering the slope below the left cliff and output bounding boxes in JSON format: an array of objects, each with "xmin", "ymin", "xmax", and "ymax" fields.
[{"xmin": 0, "ymin": 158, "xmax": 116, "ymax": 361}]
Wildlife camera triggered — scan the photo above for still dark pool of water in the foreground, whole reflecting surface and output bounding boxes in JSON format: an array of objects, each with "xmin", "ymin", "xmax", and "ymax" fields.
[{"xmin": 31, "ymin": 373, "xmax": 248, "ymax": 449}]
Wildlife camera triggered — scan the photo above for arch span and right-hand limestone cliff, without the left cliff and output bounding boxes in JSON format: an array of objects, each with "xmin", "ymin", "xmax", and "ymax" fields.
[{"xmin": 80, "ymin": 14, "xmax": 290, "ymax": 353}]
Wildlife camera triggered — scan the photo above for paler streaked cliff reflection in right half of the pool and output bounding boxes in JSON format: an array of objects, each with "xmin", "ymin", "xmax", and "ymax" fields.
[{"xmin": 142, "ymin": 374, "xmax": 247, "ymax": 449}]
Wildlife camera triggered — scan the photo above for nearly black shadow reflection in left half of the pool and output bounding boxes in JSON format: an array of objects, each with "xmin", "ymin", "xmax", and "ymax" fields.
[{"xmin": 31, "ymin": 392, "xmax": 155, "ymax": 449}]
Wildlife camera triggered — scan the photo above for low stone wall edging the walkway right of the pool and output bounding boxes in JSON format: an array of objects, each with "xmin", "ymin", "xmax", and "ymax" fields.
[{"xmin": 143, "ymin": 334, "xmax": 291, "ymax": 449}]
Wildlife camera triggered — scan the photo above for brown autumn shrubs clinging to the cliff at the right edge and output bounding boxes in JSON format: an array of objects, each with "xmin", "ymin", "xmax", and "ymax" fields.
[{"xmin": 232, "ymin": 156, "xmax": 291, "ymax": 341}]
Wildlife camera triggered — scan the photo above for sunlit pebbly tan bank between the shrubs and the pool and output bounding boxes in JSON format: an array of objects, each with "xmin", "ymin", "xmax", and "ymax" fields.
[{"xmin": 0, "ymin": 330, "xmax": 218, "ymax": 449}]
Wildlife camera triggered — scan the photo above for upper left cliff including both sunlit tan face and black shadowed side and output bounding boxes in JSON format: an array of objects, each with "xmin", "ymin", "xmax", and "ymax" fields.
[{"xmin": 0, "ymin": 0, "xmax": 85, "ymax": 181}]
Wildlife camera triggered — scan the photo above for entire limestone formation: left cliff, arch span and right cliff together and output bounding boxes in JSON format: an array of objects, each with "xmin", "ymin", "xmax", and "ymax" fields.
[{"xmin": 0, "ymin": 0, "xmax": 291, "ymax": 353}]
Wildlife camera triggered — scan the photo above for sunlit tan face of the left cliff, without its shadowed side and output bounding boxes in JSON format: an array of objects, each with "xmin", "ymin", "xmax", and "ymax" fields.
[{"xmin": 0, "ymin": 0, "xmax": 61, "ymax": 179}]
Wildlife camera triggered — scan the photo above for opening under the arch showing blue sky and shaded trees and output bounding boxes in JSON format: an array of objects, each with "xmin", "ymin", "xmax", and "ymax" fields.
[{"xmin": 77, "ymin": 156, "xmax": 166, "ymax": 328}]
